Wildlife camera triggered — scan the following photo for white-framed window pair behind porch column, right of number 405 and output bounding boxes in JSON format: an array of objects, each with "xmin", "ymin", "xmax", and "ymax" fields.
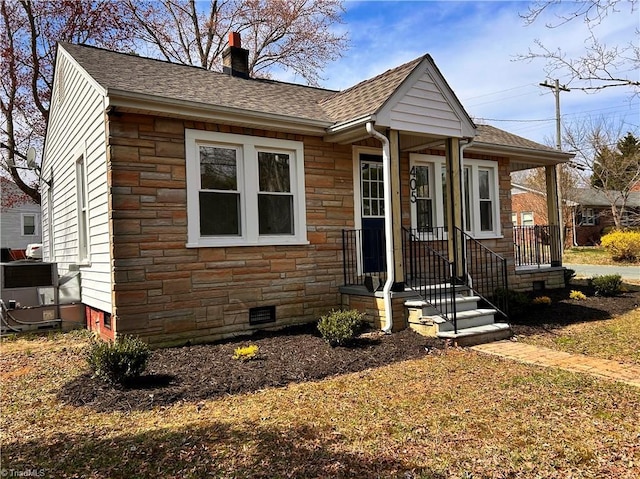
[{"xmin": 409, "ymin": 154, "xmax": 501, "ymax": 238}]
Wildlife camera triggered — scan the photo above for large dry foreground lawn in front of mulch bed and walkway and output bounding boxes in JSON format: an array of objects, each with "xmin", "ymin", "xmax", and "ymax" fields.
[{"xmin": 0, "ymin": 335, "xmax": 640, "ymax": 479}]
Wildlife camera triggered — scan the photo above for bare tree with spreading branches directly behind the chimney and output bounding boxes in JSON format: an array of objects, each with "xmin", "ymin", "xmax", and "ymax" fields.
[{"xmin": 126, "ymin": 0, "xmax": 347, "ymax": 84}]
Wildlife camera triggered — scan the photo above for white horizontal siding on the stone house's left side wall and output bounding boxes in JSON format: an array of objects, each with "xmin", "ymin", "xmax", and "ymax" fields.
[{"xmin": 43, "ymin": 48, "xmax": 112, "ymax": 312}]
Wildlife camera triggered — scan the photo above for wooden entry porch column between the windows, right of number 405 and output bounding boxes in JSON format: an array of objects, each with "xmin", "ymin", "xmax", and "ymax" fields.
[{"xmin": 445, "ymin": 138, "xmax": 465, "ymax": 278}]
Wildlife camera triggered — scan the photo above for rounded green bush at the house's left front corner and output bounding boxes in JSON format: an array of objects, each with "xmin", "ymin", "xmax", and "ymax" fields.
[{"xmin": 87, "ymin": 336, "xmax": 151, "ymax": 384}]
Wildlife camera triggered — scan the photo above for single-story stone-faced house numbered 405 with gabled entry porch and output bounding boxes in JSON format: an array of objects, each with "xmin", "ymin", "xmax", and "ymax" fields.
[{"xmin": 42, "ymin": 34, "xmax": 571, "ymax": 345}]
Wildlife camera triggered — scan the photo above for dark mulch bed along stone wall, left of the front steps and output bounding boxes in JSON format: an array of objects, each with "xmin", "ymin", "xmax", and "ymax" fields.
[{"xmin": 58, "ymin": 325, "xmax": 444, "ymax": 412}]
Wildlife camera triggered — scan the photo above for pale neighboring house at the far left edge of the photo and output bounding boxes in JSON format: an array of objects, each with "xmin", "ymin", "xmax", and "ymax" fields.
[{"xmin": 0, "ymin": 177, "xmax": 42, "ymax": 251}]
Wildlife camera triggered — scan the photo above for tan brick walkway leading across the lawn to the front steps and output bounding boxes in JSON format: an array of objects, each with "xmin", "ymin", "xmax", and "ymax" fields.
[{"xmin": 471, "ymin": 340, "xmax": 640, "ymax": 388}]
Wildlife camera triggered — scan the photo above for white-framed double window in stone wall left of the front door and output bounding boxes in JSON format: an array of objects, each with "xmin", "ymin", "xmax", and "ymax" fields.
[{"xmin": 185, "ymin": 130, "xmax": 307, "ymax": 247}]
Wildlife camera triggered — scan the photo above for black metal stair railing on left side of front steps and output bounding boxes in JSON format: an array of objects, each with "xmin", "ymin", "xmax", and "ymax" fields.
[{"xmin": 402, "ymin": 228, "xmax": 458, "ymax": 333}]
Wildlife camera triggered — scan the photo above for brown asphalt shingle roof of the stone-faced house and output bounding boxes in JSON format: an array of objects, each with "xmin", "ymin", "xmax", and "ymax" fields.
[{"xmin": 61, "ymin": 43, "xmax": 568, "ymax": 158}]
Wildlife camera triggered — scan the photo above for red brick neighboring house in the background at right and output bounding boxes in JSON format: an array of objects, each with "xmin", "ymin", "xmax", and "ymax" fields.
[{"xmin": 571, "ymin": 188, "xmax": 640, "ymax": 246}]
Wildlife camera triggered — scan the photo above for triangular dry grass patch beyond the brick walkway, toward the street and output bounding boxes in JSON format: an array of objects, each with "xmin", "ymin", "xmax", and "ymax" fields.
[{"xmin": 522, "ymin": 307, "xmax": 640, "ymax": 364}]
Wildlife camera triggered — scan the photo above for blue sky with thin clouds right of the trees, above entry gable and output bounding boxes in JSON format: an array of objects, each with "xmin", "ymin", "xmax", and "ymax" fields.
[{"xmin": 302, "ymin": 1, "xmax": 640, "ymax": 144}]
